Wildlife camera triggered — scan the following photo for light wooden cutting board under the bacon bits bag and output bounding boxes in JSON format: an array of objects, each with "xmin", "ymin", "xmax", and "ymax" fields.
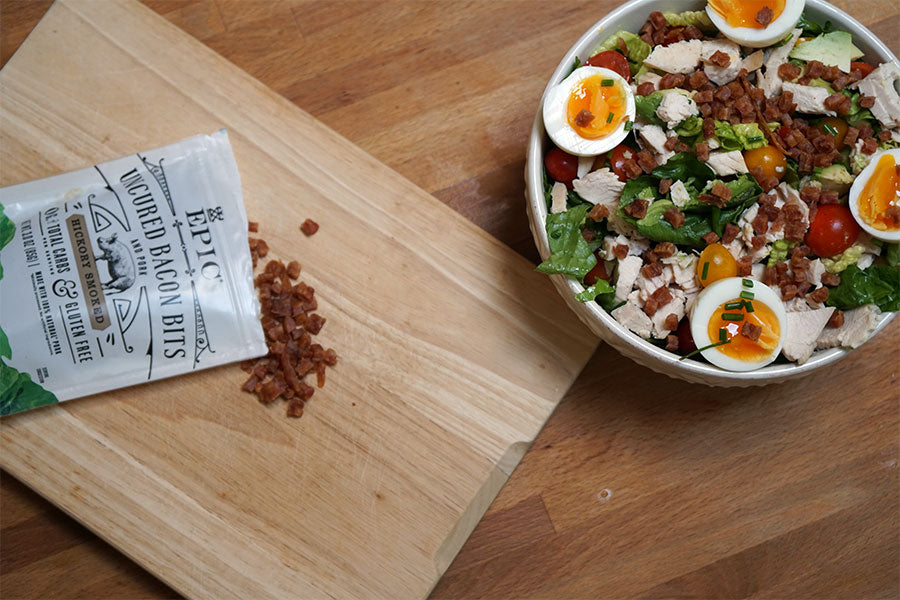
[{"xmin": 0, "ymin": 0, "xmax": 596, "ymax": 598}]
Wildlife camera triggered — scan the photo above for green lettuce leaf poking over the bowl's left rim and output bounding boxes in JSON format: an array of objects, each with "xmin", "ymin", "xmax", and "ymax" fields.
[{"xmin": 537, "ymin": 204, "xmax": 597, "ymax": 281}]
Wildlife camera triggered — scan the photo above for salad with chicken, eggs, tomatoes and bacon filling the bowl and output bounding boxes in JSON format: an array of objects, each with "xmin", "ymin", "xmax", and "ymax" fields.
[{"xmin": 538, "ymin": 0, "xmax": 900, "ymax": 371}]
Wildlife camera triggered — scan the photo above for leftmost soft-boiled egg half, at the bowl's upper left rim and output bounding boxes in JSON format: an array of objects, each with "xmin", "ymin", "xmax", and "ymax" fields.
[{"xmin": 544, "ymin": 67, "xmax": 635, "ymax": 156}]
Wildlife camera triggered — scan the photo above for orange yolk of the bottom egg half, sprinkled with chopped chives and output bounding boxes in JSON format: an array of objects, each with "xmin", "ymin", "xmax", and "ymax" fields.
[{"xmin": 707, "ymin": 298, "xmax": 781, "ymax": 362}]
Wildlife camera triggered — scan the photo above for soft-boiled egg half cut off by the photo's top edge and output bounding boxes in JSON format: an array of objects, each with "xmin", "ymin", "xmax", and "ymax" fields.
[{"xmin": 706, "ymin": 0, "xmax": 806, "ymax": 48}]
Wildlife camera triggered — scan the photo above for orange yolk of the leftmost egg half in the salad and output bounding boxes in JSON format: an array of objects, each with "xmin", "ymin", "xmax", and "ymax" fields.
[{"xmin": 566, "ymin": 74, "xmax": 626, "ymax": 140}]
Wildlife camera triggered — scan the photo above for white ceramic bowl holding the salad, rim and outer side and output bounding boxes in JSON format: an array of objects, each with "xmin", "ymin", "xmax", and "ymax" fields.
[{"xmin": 525, "ymin": 0, "xmax": 897, "ymax": 387}]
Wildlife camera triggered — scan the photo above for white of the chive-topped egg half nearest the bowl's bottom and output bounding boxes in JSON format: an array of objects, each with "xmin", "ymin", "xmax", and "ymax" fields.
[{"xmin": 690, "ymin": 277, "xmax": 787, "ymax": 371}]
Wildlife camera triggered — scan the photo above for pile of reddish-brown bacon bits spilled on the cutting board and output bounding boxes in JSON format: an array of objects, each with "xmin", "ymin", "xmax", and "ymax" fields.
[{"xmin": 241, "ymin": 220, "xmax": 337, "ymax": 417}]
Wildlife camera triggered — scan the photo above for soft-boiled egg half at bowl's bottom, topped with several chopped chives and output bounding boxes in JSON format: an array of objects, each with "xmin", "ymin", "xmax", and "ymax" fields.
[{"xmin": 691, "ymin": 277, "xmax": 787, "ymax": 371}]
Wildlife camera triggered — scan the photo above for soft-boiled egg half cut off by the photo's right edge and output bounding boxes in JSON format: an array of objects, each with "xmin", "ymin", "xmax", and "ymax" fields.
[{"xmin": 850, "ymin": 148, "xmax": 900, "ymax": 242}]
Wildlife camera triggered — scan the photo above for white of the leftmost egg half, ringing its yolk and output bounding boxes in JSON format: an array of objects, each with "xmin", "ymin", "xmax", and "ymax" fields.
[{"xmin": 543, "ymin": 67, "xmax": 635, "ymax": 156}]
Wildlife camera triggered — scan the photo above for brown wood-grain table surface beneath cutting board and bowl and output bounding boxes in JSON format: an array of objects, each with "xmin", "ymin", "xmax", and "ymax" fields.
[{"xmin": 0, "ymin": 0, "xmax": 900, "ymax": 598}]
